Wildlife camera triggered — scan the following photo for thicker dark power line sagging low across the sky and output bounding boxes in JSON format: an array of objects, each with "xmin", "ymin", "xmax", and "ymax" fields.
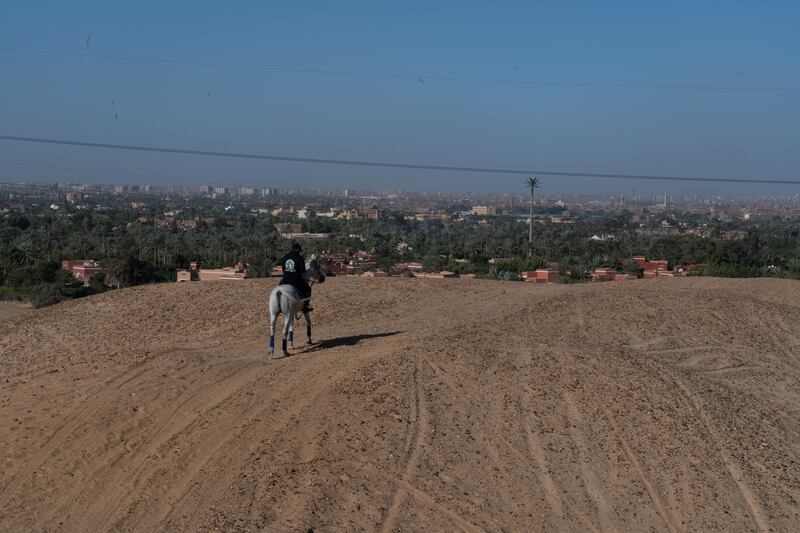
[{"xmin": 0, "ymin": 135, "xmax": 800, "ymax": 185}]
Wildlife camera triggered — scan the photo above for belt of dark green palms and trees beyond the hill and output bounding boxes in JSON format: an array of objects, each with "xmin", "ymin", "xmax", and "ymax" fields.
[{"xmin": 0, "ymin": 190, "xmax": 800, "ymax": 306}]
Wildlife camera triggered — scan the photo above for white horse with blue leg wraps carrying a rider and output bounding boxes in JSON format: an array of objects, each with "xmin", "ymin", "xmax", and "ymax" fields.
[{"xmin": 269, "ymin": 254, "xmax": 325, "ymax": 356}]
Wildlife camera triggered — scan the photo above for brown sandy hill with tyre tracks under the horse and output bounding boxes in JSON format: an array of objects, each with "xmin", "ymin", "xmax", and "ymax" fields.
[{"xmin": 0, "ymin": 278, "xmax": 800, "ymax": 531}]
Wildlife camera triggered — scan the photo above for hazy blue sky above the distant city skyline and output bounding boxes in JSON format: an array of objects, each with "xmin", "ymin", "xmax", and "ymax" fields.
[{"xmin": 0, "ymin": 0, "xmax": 800, "ymax": 194}]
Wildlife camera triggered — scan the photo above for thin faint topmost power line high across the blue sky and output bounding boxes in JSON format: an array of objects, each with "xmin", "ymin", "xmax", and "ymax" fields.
[{"xmin": 0, "ymin": 46, "xmax": 800, "ymax": 93}]
